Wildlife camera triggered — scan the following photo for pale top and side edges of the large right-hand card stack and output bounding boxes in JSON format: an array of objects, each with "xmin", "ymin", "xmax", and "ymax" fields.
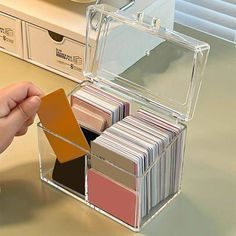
[{"xmin": 92, "ymin": 109, "xmax": 185, "ymax": 217}]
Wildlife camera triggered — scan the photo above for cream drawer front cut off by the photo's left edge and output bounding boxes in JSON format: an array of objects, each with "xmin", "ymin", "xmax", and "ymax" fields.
[{"xmin": 0, "ymin": 13, "xmax": 23, "ymax": 57}]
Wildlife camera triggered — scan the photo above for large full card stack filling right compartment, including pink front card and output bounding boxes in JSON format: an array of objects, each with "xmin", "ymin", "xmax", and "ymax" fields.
[{"xmin": 88, "ymin": 109, "xmax": 185, "ymax": 226}]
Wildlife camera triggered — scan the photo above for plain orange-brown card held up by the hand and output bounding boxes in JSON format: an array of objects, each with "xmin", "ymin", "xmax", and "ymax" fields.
[{"xmin": 38, "ymin": 89, "xmax": 90, "ymax": 163}]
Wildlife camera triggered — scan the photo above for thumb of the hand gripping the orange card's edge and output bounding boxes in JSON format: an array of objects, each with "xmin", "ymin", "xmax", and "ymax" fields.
[{"xmin": 7, "ymin": 96, "xmax": 41, "ymax": 134}]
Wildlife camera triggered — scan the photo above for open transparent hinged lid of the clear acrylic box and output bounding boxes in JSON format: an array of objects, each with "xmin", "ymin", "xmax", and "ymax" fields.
[{"xmin": 84, "ymin": 5, "xmax": 210, "ymax": 121}]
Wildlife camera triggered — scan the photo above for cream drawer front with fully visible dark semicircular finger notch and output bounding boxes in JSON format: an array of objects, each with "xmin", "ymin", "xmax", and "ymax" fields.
[{"xmin": 26, "ymin": 23, "xmax": 85, "ymax": 79}]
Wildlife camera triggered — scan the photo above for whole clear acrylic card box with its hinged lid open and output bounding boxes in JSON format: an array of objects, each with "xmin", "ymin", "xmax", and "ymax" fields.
[{"xmin": 38, "ymin": 5, "xmax": 210, "ymax": 232}]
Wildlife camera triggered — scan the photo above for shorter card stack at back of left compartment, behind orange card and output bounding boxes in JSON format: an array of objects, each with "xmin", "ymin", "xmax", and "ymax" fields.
[{"xmin": 71, "ymin": 85, "xmax": 130, "ymax": 133}]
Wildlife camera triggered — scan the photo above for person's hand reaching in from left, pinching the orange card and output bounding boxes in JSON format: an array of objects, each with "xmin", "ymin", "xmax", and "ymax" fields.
[{"xmin": 0, "ymin": 82, "xmax": 43, "ymax": 153}]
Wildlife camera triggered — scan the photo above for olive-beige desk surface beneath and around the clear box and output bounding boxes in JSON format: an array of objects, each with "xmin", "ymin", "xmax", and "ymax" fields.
[{"xmin": 0, "ymin": 24, "xmax": 236, "ymax": 236}]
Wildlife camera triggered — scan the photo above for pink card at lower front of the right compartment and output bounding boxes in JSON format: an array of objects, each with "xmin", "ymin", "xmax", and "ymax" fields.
[{"xmin": 88, "ymin": 169, "xmax": 138, "ymax": 227}]
